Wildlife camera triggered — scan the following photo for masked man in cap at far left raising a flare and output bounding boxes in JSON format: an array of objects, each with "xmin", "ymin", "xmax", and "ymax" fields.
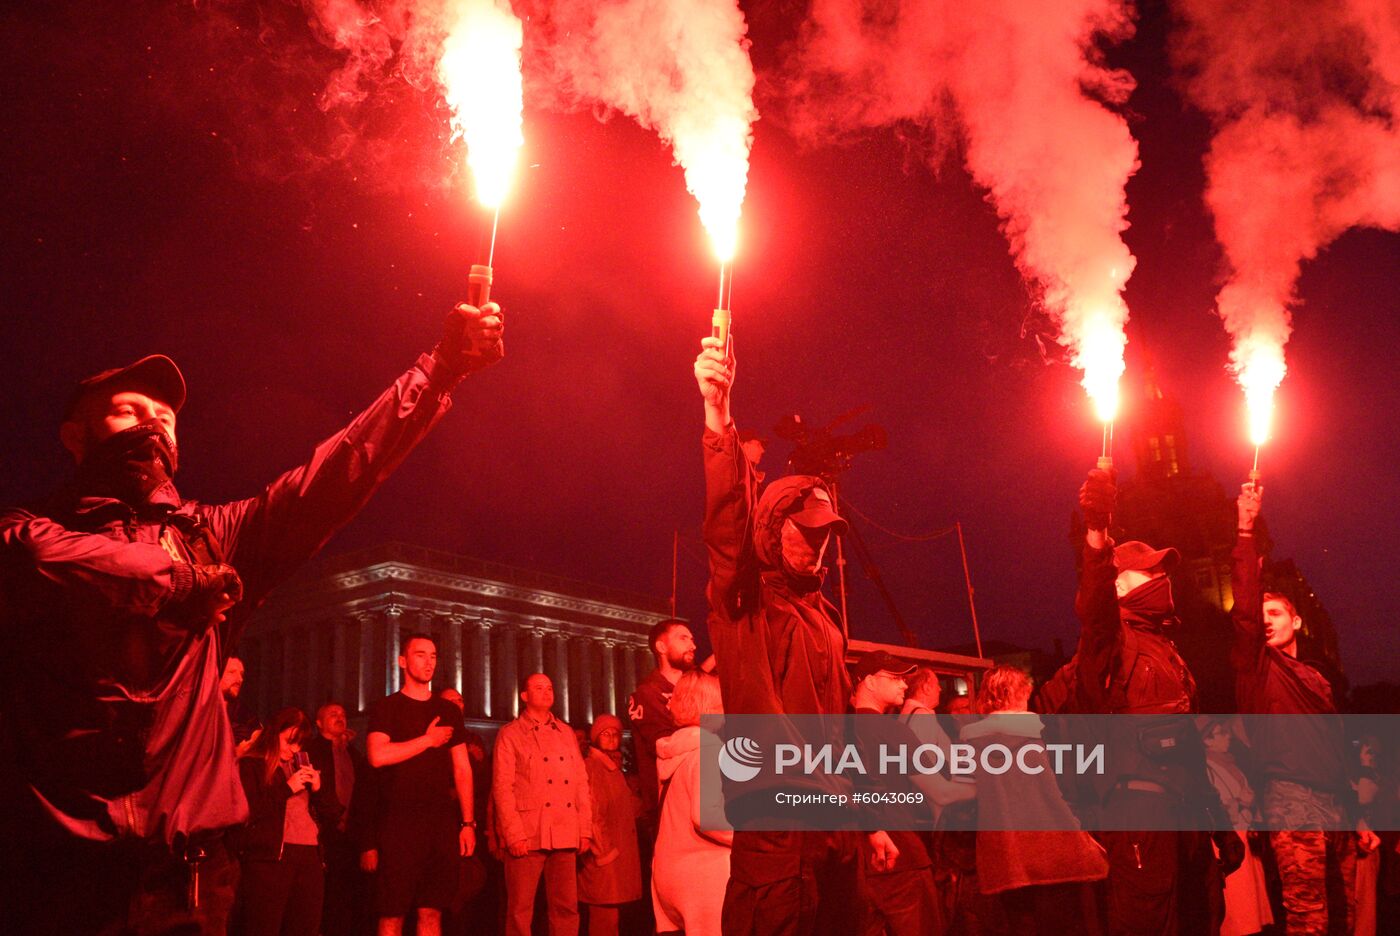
[{"xmin": 0, "ymin": 295, "xmax": 503, "ymax": 933}]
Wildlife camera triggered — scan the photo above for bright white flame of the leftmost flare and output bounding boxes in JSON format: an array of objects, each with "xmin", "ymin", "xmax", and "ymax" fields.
[{"xmin": 437, "ymin": 0, "xmax": 525, "ymax": 210}]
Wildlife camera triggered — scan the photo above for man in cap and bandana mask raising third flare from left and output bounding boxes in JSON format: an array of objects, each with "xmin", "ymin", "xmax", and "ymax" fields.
[{"xmin": 1061, "ymin": 469, "xmax": 1243, "ymax": 936}]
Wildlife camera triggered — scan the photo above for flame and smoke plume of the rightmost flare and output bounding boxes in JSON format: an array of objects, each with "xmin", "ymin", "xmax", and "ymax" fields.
[{"xmin": 1175, "ymin": 0, "xmax": 1400, "ymax": 444}]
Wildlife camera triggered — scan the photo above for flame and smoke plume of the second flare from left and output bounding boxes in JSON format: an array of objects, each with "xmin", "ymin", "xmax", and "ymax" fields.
[{"xmin": 526, "ymin": 0, "xmax": 757, "ymax": 259}]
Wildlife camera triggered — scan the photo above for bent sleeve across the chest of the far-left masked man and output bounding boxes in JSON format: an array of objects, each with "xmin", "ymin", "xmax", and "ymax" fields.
[{"xmin": 0, "ymin": 511, "xmax": 193, "ymax": 617}]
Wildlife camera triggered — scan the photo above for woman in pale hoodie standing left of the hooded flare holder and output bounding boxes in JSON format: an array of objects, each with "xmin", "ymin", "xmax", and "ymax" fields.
[{"xmin": 651, "ymin": 670, "xmax": 734, "ymax": 936}]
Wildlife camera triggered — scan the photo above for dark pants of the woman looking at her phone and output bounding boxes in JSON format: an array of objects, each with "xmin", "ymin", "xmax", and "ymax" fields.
[{"xmin": 238, "ymin": 845, "xmax": 326, "ymax": 936}]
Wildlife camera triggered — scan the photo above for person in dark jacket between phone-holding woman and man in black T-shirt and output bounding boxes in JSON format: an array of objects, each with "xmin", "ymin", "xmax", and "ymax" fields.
[{"xmin": 302, "ymin": 702, "xmax": 374, "ymax": 936}]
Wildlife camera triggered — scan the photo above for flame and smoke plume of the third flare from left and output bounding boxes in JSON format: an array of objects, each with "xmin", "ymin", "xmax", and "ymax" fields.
[{"xmin": 791, "ymin": 0, "xmax": 1138, "ymax": 418}]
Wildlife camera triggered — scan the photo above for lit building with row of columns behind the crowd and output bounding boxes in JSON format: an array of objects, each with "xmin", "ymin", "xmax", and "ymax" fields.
[{"xmin": 238, "ymin": 543, "xmax": 669, "ymax": 728}]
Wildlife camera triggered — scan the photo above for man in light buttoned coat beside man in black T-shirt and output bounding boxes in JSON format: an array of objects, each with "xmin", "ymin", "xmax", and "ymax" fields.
[{"xmin": 491, "ymin": 673, "xmax": 592, "ymax": 936}]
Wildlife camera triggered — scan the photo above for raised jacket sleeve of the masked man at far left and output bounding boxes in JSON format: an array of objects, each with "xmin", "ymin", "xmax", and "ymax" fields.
[{"xmin": 206, "ymin": 354, "xmax": 455, "ymax": 613}]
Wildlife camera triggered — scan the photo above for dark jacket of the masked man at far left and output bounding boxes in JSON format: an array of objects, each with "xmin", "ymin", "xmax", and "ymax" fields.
[{"xmin": 0, "ymin": 355, "xmax": 455, "ymax": 846}]
